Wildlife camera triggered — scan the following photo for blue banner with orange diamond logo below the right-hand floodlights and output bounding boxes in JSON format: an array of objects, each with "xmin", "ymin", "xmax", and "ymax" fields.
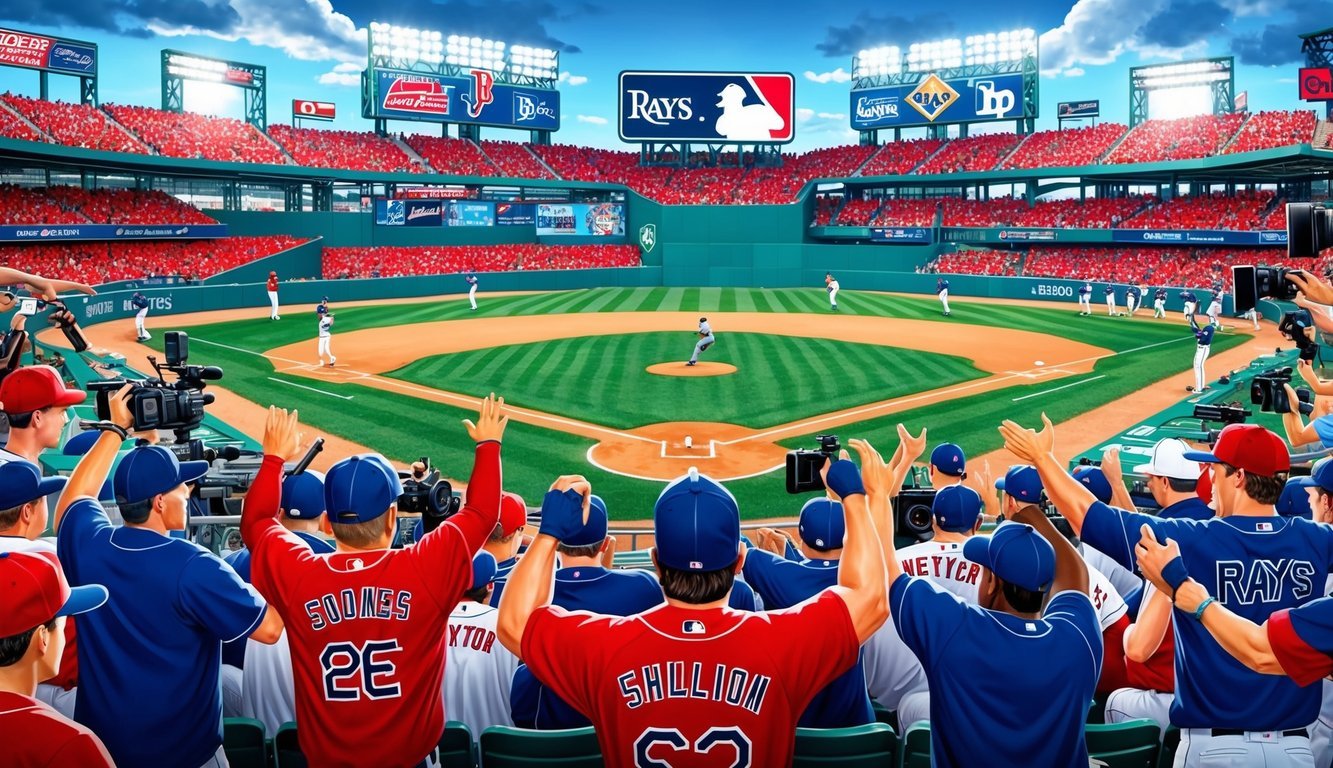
[{"xmin": 850, "ymin": 73, "xmax": 1024, "ymax": 131}]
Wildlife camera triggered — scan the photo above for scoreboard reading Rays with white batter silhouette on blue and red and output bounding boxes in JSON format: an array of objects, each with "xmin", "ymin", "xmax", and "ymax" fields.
[{"xmin": 619, "ymin": 72, "xmax": 796, "ymax": 144}]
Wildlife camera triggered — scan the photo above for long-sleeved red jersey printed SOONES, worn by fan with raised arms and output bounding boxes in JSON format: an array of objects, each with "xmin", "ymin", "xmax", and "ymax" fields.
[{"xmin": 241, "ymin": 440, "xmax": 500, "ymax": 767}]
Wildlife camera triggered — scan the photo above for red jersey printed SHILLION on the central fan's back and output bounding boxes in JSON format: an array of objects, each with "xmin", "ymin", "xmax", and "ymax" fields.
[{"xmin": 523, "ymin": 591, "xmax": 860, "ymax": 768}]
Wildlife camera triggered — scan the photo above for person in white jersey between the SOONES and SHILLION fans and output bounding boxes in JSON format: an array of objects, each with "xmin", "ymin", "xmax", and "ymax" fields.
[{"xmin": 443, "ymin": 549, "xmax": 519, "ymax": 733}]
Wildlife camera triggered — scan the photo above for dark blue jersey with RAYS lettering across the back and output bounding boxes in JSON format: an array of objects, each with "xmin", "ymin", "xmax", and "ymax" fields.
[{"xmin": 1081, "ymin": 501, "xmax": 1333, "ymax": 731}]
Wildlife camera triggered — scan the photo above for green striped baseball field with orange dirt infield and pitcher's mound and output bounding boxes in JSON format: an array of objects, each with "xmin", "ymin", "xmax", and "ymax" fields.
[{"xmin": 106, "ymin": 288, "xmax": 1250, "ymax": 520}]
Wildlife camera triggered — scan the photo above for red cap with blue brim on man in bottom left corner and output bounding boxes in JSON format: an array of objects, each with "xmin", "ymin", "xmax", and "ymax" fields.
[{"xmin": 0, "ymin": 552, "xmax": 107, "ymax": 637}]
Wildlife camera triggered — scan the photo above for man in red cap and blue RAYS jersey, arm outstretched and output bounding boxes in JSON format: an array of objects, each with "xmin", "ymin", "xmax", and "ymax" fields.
[{"xmin": 1000, "ymin": 417, "xmax": 1333, "ymax": 767}]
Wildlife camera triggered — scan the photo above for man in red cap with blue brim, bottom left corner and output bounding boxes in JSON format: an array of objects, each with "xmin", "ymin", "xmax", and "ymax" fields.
[{"xmin": 0, "ymin": 552, "xmax": 115, "ymax": 768}]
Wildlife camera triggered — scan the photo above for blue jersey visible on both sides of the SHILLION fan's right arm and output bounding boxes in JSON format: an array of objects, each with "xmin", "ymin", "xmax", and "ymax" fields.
[{"xmin": 744, "ymin": 549, "xmax": 874, "ymax": 728}]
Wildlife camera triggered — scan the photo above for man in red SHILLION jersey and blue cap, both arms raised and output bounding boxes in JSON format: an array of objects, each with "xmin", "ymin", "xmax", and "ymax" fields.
[{"xmin": 497, "ymin": 440, "xmax": 901, "ymax": 768}]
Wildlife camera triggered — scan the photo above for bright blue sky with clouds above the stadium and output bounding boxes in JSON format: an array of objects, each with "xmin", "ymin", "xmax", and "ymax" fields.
[{"xmin": 0, "ymin": 0, "xmax": 1317, "ymax": 151}]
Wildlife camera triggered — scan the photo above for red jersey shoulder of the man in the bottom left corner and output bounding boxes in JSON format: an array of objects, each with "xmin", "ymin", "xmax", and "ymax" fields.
[{"xmin": 0, "ymin": 691, "xmax": 116, "ymax": 768}]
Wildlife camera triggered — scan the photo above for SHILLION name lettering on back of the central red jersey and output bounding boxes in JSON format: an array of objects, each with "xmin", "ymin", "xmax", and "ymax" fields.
[{"xmin": 616, "ymin": 661, "xmax": 773, "ymax": 715}]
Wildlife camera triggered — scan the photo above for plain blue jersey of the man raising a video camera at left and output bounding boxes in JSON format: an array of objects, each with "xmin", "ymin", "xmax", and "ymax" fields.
[{"xmin": 57, "ymin": 499, "xmax": 265, "ymax": 768}]
